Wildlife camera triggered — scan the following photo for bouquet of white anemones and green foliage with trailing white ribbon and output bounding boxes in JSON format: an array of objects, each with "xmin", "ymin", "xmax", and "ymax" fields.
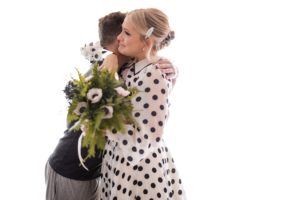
[{"xmin": 64, "ymin": 63, "xmax": 138, "ymax": 164}]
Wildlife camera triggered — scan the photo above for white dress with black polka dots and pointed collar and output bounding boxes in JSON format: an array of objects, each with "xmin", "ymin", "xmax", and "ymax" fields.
[{"xmin": 100, "ymin": 59, "xmax": 185, "ymax": 200}]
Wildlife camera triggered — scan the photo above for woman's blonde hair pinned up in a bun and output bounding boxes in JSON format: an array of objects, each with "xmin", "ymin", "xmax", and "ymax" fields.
[{"xmin": 126, "ymin": 8, "xmax": 175, "ymax": 51}]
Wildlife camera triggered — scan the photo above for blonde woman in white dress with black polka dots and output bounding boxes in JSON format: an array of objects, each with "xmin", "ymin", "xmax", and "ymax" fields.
[{"xmin": 100, "ymin": 8, "xmax": 185, "ymax": 200}]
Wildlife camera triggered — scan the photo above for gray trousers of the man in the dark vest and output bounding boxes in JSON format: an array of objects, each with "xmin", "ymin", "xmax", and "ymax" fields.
[{"xmin": 45, "ymin": 162, "xmax": 100, "ymax": 200}]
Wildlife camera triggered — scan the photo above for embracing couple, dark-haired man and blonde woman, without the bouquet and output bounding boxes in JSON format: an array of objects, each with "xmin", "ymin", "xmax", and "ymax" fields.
[{"xmin": 45, "ymin": 8, "xmax": 185, "ymax": 200}]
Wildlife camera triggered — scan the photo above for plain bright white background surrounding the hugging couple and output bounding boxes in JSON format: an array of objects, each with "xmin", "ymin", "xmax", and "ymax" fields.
[{"xmin": 0, "ymin": 0, "xmax": 300, "ymax": 200}]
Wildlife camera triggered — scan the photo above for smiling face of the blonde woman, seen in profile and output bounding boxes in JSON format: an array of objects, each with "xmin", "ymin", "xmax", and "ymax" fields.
[{"xmin": 118, "ymin": 17, "xmax": 146, "ymax": 60}]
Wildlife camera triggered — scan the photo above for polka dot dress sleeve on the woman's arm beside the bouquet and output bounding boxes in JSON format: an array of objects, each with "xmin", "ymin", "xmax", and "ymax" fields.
[{"xmin": 115, "ymin": 66, "xmax": 171, "ymax": 165}]
